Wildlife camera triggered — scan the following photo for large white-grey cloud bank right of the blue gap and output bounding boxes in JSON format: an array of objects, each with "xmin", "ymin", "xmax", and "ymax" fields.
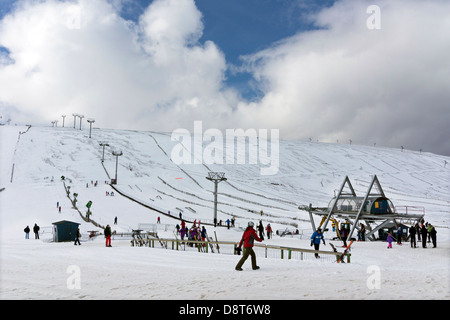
[{"xmin": 239, "ymin": 0, "xmax": 450, "ymax": 154}]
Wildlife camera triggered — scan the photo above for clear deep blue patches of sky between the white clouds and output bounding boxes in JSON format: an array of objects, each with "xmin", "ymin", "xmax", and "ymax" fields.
[{"xmin": 110, "ymin": 0, "xmax": 334, "ymax": 100}]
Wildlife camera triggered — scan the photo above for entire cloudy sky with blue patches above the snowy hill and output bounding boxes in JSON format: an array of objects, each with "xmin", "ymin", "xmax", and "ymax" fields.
[{"xmin": 0, "ymin": 0, "xmax": 450, "ymax": 155}]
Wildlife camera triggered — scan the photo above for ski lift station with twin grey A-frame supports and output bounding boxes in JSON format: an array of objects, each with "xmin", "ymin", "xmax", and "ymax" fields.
[{"xmin": 299, "ymin": 175, "xmax": 425, "ymax": 241}]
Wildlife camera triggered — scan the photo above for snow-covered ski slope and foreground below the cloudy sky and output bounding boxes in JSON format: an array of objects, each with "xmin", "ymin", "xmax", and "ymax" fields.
[{"xmin": 0, "ymin": 126, "xmax": 450, "ymax": 300}]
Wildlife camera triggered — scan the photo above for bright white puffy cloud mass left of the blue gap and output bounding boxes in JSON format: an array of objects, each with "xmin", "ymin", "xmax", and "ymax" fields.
[{"xmin": 0, "ymin": 0, "xmax": 237, "ymax": 130}]
